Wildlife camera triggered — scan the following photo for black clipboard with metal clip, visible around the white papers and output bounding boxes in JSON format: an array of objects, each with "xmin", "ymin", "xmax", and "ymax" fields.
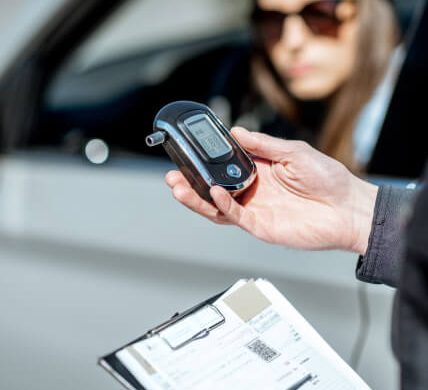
[{"xmin": 98, "ymin": 289, "xmax": 228, "ymax": 390}]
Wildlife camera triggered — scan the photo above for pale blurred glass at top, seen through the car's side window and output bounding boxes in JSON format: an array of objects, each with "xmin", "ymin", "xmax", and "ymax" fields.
[{"xmin": 66, "ymin": 0, "xmax": 250, "ymax": 72}]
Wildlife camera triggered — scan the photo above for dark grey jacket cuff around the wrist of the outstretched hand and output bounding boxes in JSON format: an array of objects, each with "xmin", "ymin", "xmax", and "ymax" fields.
[{"xmin": 356, "ymin": 186, "xmax": 414, "ymax": 287}]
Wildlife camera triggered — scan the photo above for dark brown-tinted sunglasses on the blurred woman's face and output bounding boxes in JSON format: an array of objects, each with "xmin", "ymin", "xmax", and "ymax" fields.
[{"xmin": 252, "ymin": 0, "xmax": 350, "ymax": 41}]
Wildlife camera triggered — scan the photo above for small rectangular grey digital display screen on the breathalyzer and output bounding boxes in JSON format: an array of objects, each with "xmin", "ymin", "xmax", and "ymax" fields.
[{"xmin": 184, "ymin": 114, "xmax": 232, "ymax": 158}]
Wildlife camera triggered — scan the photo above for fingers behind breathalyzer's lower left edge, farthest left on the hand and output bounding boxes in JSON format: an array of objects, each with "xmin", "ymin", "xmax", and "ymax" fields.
[{"xmin": 165, "ymin": 171, "xmax": 230, "ymax": 224}]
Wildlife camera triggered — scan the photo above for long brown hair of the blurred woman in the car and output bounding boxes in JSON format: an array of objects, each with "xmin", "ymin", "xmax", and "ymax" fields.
[{"xmin": 251, "ymin": 0, "xmax": 399, "ymax": 171}]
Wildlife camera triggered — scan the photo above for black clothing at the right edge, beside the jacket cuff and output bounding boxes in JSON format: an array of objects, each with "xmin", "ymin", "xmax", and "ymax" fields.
[{"xmin": 395, "ymin": 166, "xmax": 428, "ymax": 390}]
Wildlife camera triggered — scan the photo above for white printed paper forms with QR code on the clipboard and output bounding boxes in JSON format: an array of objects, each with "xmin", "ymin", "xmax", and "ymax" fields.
[{"xmin": 117, "ymin": 279, "xmax": 369, "ymax": 390}]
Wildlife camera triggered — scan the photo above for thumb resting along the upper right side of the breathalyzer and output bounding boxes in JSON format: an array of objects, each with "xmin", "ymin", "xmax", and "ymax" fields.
[{"xmin": 232, "ymin": 127, "xmax": 299, "ymax": 162}]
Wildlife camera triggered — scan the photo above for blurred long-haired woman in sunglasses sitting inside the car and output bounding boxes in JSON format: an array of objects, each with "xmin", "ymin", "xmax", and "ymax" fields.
[{"xmin": 244, "ymin": 0, "xmax": 399, "ymax": 170}]
